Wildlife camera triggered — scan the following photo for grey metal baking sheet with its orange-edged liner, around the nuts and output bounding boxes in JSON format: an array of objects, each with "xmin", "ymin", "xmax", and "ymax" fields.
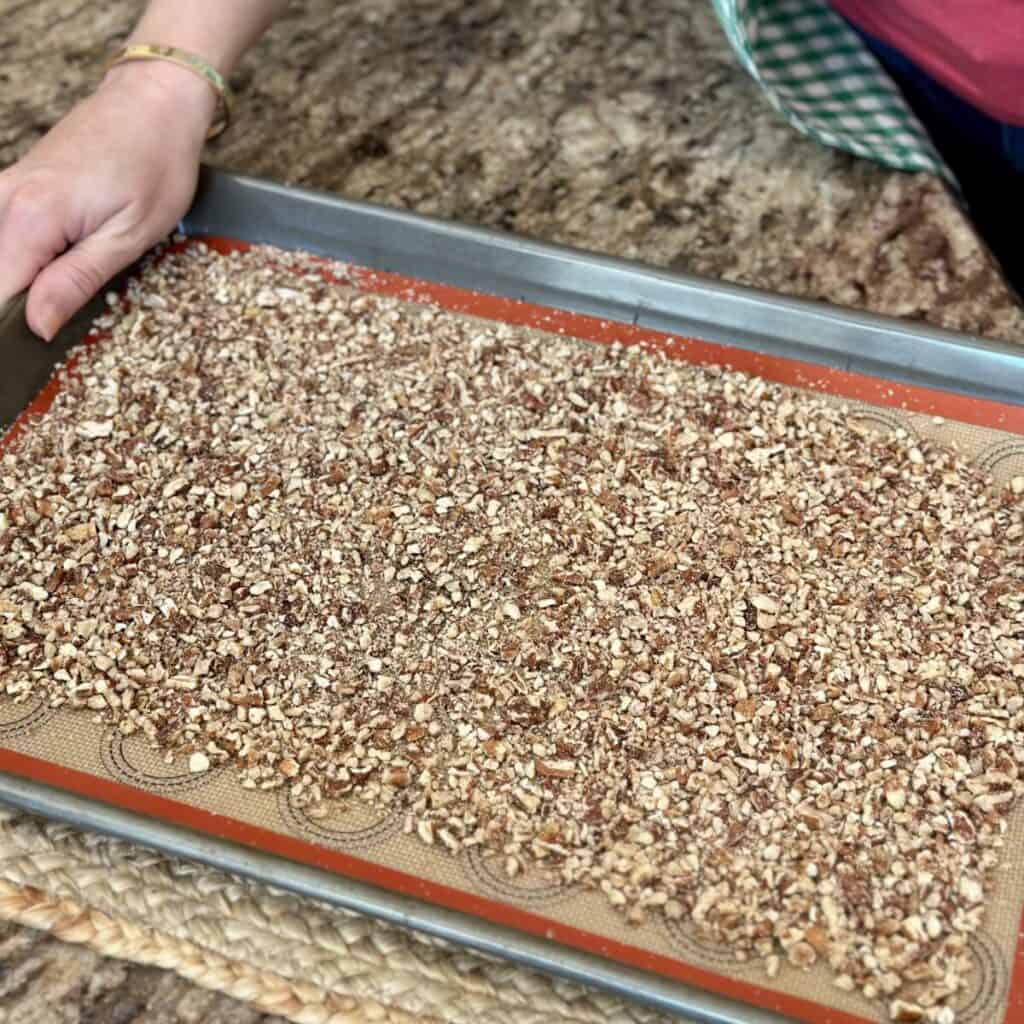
[{"xmin": 0, "ymin": 167, "xmax": 1024, "ymax": 1024}]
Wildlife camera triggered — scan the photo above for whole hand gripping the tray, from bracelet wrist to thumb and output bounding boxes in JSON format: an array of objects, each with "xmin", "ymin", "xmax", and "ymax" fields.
[{"xmin": 0, "ymin": 61, "xmax": 216, "ymax": 341}]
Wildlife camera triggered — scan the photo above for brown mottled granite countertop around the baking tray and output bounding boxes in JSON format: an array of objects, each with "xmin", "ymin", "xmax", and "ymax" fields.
[{"xmin": 0, "ymin": 0, "xmax": 1024, "ymax": 1022}]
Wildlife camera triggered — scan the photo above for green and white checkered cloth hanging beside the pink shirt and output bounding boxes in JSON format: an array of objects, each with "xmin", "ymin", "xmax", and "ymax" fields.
[{"xmin": 713, "ymin": 0, "xmax": 955, "ymax": 185}]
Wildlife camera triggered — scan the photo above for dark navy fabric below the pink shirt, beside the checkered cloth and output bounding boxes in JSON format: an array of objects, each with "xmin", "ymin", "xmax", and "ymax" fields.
[{"xmin": 853, "ymin": 26, "xmax": 1024, "ymax": 296}]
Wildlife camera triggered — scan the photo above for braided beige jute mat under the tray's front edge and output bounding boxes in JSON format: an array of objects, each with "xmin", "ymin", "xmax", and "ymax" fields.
[{"xmin": 0, "ymin": 807, "xmax": 667, "ymax": 1024}]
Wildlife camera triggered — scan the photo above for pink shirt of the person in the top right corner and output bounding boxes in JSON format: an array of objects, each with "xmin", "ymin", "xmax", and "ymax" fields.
[{"xmin": 829, "ymin": 0, "xmax": 1024, "ymax": 125}]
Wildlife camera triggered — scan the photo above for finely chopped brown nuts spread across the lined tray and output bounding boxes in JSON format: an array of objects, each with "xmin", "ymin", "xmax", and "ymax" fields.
[{"xmin": 0, "ymin": 239, "xmax": 1024, "ymax": 1024}]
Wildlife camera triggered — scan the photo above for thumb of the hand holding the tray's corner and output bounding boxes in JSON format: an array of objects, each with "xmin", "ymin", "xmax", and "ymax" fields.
[{"xmin": 25, "ymin": 220, "xmax": 147, "ymax": 341}]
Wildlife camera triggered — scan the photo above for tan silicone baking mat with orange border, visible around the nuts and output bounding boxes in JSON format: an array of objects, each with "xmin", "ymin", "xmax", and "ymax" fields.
[{"xmin": 0, "ymin": 230, "xmax": 1024, "ymax": 1024}]
